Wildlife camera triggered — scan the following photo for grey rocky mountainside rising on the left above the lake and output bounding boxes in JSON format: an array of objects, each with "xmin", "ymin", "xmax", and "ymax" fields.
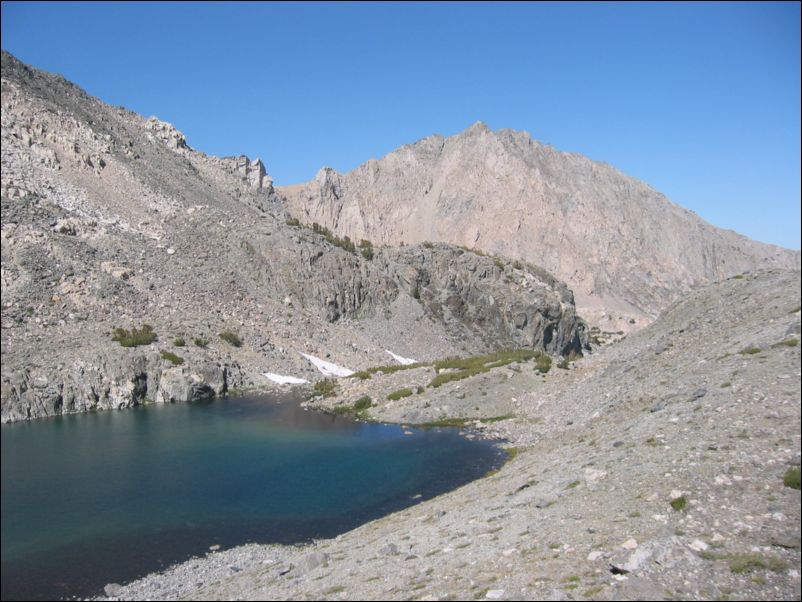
[{"xmin": 0, "ymin": 52, "xmax": 586, "ymax": 422}]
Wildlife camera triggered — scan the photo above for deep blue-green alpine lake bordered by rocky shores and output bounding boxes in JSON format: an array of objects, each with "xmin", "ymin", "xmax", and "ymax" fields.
[{"xmin": 2, "ymin": 396, "xmax": 504, "ymax": 600}]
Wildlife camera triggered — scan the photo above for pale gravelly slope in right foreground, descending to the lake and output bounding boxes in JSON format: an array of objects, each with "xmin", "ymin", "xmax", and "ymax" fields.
[{"xmin": 97, "ymin": 271, "xmax": 802, "ymax": 600}]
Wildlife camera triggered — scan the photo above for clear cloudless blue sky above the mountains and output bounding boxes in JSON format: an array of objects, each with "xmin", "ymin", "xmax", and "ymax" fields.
[{"xmin": 2, "ymin": 2, "xmax": 800, "ymax": 249}]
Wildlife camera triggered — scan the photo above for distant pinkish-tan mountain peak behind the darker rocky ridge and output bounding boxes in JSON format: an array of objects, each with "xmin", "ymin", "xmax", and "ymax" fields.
[{"xmin": 278, "ymin": 123, "xmax": 800, "ymax": 330}]
